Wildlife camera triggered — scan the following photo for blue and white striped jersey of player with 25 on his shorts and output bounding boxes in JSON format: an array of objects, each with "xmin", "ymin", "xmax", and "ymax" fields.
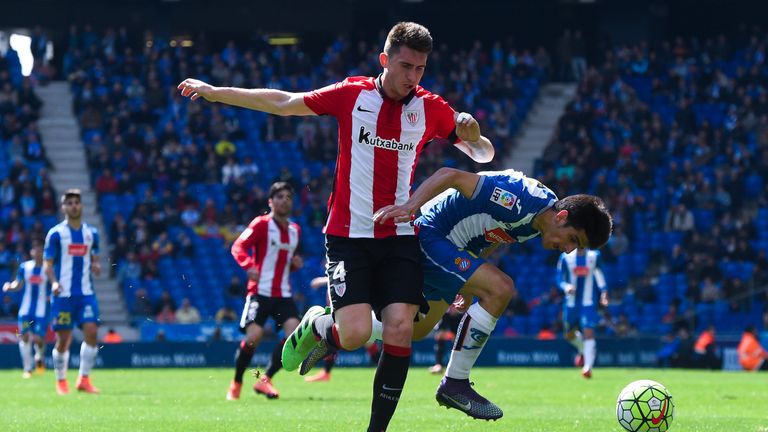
[{"xmin": 43, "ymin": 221, "xmax": 99, "ymax": 297}]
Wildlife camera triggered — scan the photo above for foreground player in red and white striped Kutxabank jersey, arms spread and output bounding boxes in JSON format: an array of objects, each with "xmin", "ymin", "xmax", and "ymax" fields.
[{"xmin": 179, "ymin": 23, "xmax": 494, "ymax": 432}]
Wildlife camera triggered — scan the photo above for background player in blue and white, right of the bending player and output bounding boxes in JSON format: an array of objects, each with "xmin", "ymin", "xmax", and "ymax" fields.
[{"xmin": 557, "ymin": 249, "xmax": 608, "ymax": 378}]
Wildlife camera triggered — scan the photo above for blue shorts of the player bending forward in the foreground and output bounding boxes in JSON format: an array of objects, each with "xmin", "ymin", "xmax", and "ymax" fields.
[{"xmin": 419, "ymin": 226, "xmax": 485, "ymax": 304}]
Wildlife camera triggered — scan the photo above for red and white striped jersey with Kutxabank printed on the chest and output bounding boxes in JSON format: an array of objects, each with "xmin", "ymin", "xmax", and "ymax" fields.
[{"xmin": 304, "ymin": 73, "xmax": 457, "ymax": 238}]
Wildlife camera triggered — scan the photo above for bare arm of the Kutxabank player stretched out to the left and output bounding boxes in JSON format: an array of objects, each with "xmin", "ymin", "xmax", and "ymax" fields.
[{"xmin": 177, "ymin": 78, "xmax": 316, "ymax": 116}]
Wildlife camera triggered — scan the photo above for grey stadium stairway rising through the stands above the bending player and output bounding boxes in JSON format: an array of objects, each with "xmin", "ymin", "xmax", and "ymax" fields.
[{"xmin": 503, "ymin": 83, "xmax": 576, "ymax": 176}]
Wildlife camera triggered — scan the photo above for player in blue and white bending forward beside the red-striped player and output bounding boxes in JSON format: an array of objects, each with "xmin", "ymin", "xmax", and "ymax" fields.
[{"xmin": 354, "ymin": 168, "xmax": 612, "ymax": 419}]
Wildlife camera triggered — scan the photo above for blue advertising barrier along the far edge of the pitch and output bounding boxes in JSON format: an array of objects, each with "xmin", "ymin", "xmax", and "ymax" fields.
[{"xmin": 0, "ymin": 324, "xmax": 739, "ymax": 370}]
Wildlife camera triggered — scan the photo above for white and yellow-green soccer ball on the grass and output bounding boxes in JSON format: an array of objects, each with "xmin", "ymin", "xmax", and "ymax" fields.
[{"xmin": 616, "ymin": 380, "xmax": 675, "ymax": 432}]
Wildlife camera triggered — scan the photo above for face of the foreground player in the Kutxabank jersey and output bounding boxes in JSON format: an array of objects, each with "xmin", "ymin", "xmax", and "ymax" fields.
[{"xmin": 379, "ymin": 46, "xmax": 428, "ymax": 99}]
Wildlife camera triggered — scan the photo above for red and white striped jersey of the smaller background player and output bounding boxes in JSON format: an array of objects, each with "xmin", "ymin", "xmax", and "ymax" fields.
[{"xmin": 232, "ymin": 215, "xmax": 301, "ymax": 297}]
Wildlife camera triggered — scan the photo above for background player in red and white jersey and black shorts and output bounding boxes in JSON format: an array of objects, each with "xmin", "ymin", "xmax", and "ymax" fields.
[{"xmin": 227, "ymin": 182, "xmax": 303, "ymax": 400}]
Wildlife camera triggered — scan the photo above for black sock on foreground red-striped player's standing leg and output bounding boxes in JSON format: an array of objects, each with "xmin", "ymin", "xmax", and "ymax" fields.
[{"xmin": 368, "ymin": 344, "xmax": 411, "ymax": 432}]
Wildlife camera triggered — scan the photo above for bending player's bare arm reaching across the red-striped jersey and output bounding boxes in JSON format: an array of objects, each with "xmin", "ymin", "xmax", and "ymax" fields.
[{"xmin": 373, "ymin": 167, "xmax": 480, "ymax": 223}]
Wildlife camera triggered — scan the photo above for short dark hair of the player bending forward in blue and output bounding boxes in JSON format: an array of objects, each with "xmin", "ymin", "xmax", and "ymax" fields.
[{"xmin": 554, "ymin": 194, "xmax": 613, "ymax": 249}]
